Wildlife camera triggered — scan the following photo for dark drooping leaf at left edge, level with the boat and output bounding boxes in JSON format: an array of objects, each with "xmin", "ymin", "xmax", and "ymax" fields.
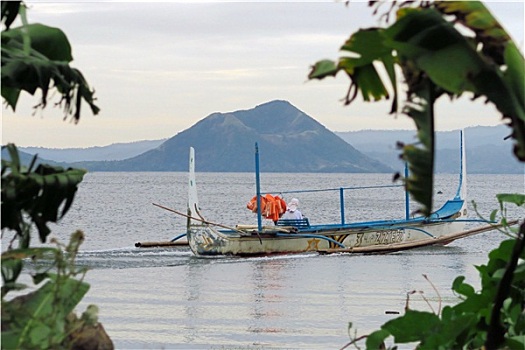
[{"xmin": 1, "ymin": 144, "xmax": 85, "ymax": 308}]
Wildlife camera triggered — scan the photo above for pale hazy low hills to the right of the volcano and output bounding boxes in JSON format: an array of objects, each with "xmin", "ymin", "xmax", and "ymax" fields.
[{"xmin": 335, "ymin": 125, "xmax": 524, "ymax": 174}]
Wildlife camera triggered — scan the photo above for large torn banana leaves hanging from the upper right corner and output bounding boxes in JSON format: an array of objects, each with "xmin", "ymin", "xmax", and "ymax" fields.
[{"xmin": 309, "ymin": 1, "xmax": 525, "ymax": 214}]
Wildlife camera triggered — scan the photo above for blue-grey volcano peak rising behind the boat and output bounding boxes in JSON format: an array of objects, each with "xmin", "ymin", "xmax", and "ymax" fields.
[{"xmin": 67, "ymin": 101, "xmax": 392, "ymax": 173}]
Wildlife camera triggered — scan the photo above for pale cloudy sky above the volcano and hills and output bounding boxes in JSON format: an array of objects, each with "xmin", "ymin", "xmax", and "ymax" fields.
[{"xmin": 2, "ymin": 0, "xmax": 525, "ymax": 148}]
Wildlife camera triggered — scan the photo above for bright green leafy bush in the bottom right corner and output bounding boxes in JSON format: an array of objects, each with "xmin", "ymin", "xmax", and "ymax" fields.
[{"xmin": 342, "ymin": 194, "xmax": 525, "ymax": 350}]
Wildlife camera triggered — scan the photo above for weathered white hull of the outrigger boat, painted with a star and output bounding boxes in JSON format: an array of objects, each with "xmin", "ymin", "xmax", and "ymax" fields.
[{"xmin": 188, "ymin": 221, "xmax": 464, "ymax": 256}]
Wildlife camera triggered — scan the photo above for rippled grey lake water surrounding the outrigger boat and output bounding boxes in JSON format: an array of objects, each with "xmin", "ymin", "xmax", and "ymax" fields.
[{"xmin": 2, "ymin": 173, "xmax": 525, "ymax": 349}]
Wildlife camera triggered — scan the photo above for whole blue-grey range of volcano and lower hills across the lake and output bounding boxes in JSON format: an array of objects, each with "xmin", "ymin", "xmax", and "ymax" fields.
[{"xmin": 11, "ymin": 101, "xmax": 525, "ymax": 174}]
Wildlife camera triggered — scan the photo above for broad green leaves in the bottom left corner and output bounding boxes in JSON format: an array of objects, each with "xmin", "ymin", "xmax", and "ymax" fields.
[{"xmin": 2, "ymin": 231, "xmax": 89, "ymax": 349}]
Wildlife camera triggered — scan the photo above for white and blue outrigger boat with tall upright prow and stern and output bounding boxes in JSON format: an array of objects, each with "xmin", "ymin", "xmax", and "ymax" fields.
[{"xmin": 176, "ymin": 132, "xmax": 494, "ymax": 257}]
